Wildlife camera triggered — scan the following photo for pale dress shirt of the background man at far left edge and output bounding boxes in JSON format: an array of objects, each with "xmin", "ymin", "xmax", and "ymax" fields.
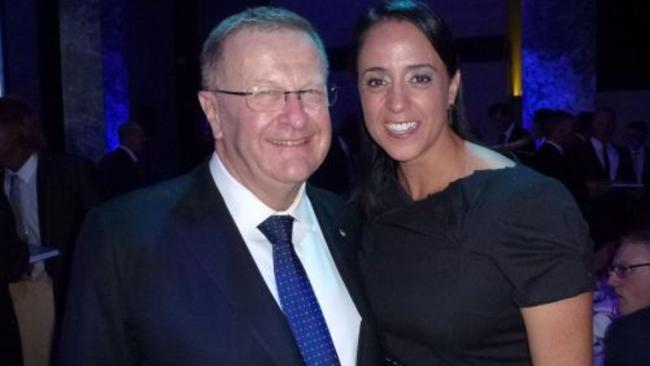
[{"xmin": 4, "ymin": 153, "xmax": 45, "ymax": 278}]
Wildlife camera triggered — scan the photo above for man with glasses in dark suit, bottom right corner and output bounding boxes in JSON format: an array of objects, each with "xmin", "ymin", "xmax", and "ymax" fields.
[{"xmin": 605, "ymin": 230, "xmax": 650, "ymax": 366}]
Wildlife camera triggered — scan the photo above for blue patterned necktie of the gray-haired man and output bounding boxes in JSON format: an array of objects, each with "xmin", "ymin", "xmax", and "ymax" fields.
[{"xmin": 257, "ymin": 215, "xmax": 340, "ymax": 366}]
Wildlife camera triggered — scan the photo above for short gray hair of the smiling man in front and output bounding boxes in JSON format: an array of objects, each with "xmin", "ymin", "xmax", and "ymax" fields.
[{"xmin": 201, "ymin": 6, "xmax": 329, "ymax": 90}]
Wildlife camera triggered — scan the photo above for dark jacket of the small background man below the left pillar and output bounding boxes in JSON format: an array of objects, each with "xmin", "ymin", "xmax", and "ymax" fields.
[{"xmin": 97, "ymin": 148, "xmax": 142, "ymax": 199}]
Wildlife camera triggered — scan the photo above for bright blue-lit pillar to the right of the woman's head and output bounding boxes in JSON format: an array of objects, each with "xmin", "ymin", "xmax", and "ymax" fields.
[{"xmin": 521, "ymin": 0, "xmax": 596, "ymax": 126}]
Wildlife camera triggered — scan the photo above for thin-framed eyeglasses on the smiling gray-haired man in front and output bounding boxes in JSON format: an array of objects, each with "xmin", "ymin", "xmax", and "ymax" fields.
[{"xmin": 208, "ymin": 85, "xmax": 337, "ymax": 112}]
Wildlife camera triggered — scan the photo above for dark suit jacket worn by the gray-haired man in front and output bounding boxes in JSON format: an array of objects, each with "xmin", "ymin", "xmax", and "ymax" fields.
[{"xmin": 62, "ymin": 164, "xmax": 379, "ymax": 366}]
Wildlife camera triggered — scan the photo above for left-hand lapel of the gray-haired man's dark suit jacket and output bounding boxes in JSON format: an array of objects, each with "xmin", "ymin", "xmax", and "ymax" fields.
[{"xmin": 177, "ymin": 164, "xmax": 303, "ymax": 365}]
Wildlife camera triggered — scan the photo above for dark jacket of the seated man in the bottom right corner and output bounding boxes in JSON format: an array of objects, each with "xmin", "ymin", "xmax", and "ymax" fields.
[{"xmin": 605, "ymin": 308, "xmax": 650, "ymax": 366}]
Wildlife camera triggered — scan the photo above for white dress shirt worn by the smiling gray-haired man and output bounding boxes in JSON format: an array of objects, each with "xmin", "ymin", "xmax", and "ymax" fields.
[{"xmin": 210, "ymin": 153, "xmax": 361, "ymax": 366}]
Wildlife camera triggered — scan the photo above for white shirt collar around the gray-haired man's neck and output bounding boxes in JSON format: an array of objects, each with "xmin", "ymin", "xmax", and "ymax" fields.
[{"xmin": 209, "ymin": 153, "xmax": 315, "ymax": 236}]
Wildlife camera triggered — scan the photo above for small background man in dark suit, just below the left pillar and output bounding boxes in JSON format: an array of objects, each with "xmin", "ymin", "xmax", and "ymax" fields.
[{"xmin": 97, "ymin": 121, "xmax": 145, "ymax": 199}]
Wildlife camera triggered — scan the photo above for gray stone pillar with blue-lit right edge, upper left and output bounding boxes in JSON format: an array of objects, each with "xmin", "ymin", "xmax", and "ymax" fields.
[{"xmin": 59, "ymin": 0, "xmax": 128, "ymax": 160}]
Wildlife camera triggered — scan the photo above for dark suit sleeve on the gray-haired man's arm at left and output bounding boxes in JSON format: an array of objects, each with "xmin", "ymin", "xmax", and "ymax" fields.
[{"xmin": 60, "ymin": 210, "xmax": 135, "ymax": 366}]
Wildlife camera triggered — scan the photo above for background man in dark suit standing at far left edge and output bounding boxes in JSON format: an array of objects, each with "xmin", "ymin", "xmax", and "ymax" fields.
[{"xmin": 0, "ymin": 96, "xmax": 97, "ymax": 365}]
